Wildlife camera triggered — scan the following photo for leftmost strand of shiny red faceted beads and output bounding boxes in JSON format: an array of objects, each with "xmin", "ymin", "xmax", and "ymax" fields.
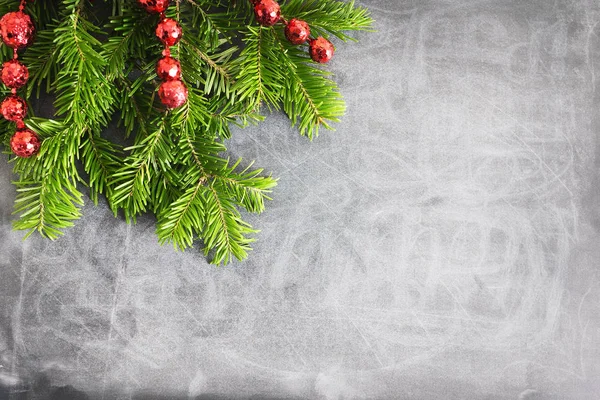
[{"xmin": 0, "ymin": 0, "xmax": 42, "ymax": 157}]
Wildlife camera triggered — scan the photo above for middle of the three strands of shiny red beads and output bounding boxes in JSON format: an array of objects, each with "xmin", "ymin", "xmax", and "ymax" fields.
[{"xmin": 138, "ymin": 0, "xmax": 188, "ymax": 108}]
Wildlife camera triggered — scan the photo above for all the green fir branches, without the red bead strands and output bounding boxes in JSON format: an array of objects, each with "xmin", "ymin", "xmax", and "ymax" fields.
[{"xmin": 0, "ymin": 0, "xmax": 372, "ymax": 264}]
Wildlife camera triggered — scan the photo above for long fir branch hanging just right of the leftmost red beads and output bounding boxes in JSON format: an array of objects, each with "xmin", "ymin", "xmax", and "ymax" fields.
[{"xmin": 48, "ymin": 0, "xmax": 118, "ymax": 206}]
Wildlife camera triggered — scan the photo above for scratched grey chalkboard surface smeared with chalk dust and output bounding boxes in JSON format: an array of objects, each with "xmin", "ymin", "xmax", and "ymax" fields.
[{"xmin": 0, "ymin": 0, "xmax": 600, "ymax": 400}]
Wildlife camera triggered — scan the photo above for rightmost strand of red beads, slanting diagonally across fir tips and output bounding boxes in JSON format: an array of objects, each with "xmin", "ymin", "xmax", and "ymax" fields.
[{"xmin": 250, "ymin": 0, "xmax": 335, "ymax": 63}]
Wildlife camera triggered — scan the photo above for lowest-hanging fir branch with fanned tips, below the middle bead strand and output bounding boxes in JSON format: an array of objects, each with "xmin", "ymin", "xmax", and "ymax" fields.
[{"xmin": 153, "ymin": 90, "xmax": 276, "ymax": 264}]
